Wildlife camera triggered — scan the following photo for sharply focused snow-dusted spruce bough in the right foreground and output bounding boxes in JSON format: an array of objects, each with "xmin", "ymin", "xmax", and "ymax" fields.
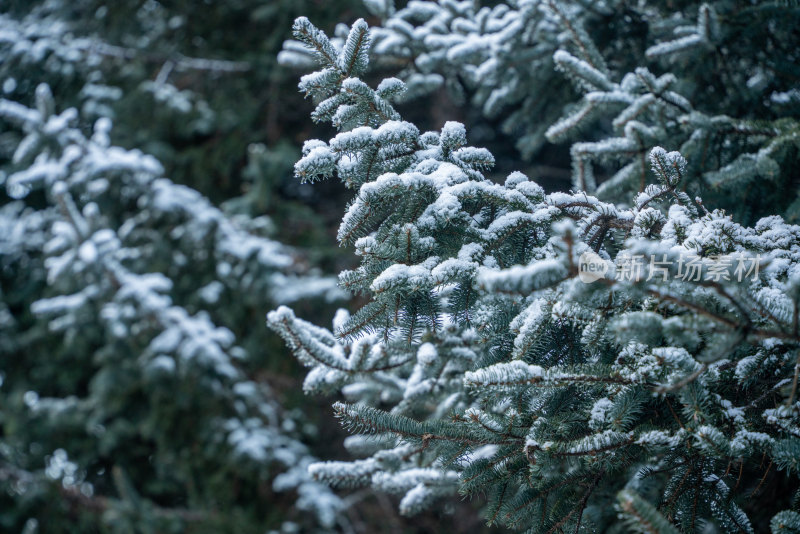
[{"xmin": 267, "ymin": 7, "xmax": 800, "ymax": 533}]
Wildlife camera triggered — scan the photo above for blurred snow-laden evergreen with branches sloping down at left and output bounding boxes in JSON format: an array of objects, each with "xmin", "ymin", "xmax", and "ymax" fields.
[{"xmin": 0, "ymin": 81, "xmax": 342, "ymax": 532}]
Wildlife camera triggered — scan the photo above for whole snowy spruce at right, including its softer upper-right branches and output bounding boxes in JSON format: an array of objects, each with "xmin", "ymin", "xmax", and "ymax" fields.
[{"xmin": 267, "ymin": 12, "xmax": 800, "ymax": 533}]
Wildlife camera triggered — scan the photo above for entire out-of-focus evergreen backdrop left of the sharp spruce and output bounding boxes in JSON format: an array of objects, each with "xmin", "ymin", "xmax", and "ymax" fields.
[{"xmin": 0, "ymin": 0, "xmax": 362, "ymax": 533}]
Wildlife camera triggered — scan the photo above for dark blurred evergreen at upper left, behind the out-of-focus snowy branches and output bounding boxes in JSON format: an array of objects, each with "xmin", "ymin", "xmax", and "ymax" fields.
[{"xmin": 0, "ymin": 0, "xmax": 362, "ymax": 205}]
